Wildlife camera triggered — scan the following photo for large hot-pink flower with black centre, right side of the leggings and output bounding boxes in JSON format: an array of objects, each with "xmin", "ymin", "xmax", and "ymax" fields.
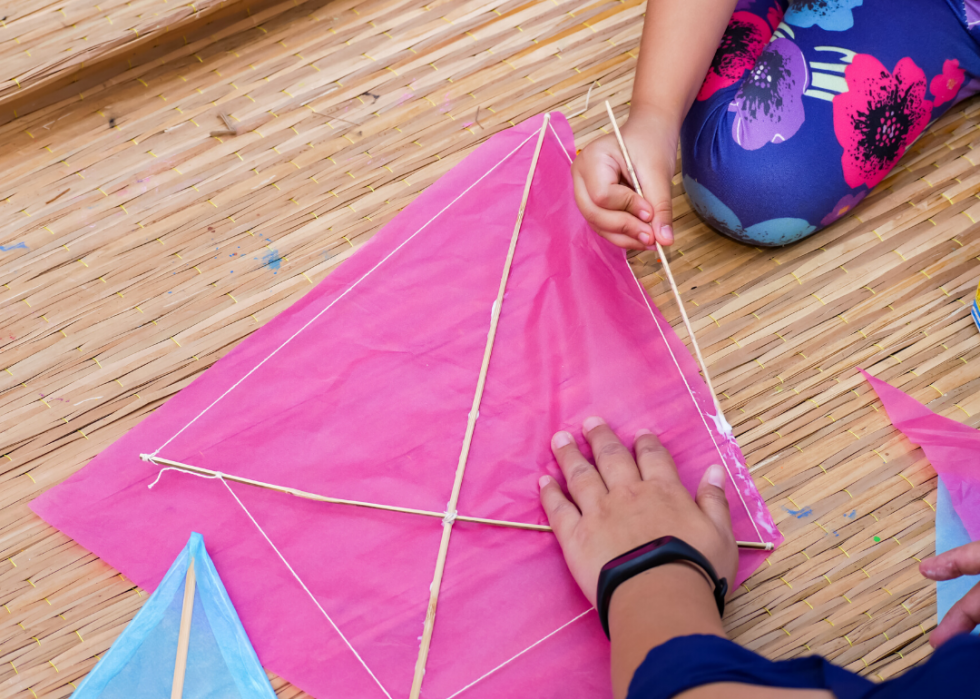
[{"xmin": 834, "ymin": 54, "xmax": 932, "ymax": 189}]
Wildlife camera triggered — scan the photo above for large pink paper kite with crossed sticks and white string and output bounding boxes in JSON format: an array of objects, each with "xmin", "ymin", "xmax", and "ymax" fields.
[{"xmin": 33, "ymin": 115, "xmax": 782, "ymax": 699}]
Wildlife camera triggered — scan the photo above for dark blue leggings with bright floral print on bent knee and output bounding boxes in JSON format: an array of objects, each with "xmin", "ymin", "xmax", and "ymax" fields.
[{"xmin": 681, "ymin": 0, "xmax": 980, "ymax": 246}]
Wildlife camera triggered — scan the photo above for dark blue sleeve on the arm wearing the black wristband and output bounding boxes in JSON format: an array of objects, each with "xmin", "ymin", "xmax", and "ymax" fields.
[{"xmin": 627, "ymin": 635, "xmax": 980, "ymax": 699}]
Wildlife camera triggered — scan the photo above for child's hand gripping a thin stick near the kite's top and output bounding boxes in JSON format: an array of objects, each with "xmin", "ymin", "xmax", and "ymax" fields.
[{"xmin": 572, "ymin": 113, "xmax": 679, "ymax": 250}]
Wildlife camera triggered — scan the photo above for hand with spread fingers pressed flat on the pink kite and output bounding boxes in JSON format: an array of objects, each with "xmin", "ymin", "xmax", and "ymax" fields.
[{"xmin": 540, "ymin": 417, "xmax": 738, "ymax": 606}]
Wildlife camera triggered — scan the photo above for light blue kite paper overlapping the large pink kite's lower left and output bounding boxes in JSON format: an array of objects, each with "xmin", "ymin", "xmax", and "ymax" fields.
[{"xmin": 73, "ymin": 533, "xmax": 276, "ymax": 699}]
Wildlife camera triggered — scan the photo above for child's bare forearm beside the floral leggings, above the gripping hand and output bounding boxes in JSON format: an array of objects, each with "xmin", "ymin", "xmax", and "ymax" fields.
[{"xmin": 631, "ymin": 0, "xmax": 736, "ymax": 131}]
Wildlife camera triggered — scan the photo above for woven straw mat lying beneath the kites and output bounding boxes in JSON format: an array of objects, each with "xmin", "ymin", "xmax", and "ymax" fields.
[{"xmin": 0, "ymin": 0, "xmax": 980, "ymax": 697}]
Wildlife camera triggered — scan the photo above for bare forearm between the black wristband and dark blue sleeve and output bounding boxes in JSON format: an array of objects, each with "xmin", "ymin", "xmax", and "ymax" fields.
[{"xmin": 609, "ymin": 563, "xmax": 725, "ymax": 699}]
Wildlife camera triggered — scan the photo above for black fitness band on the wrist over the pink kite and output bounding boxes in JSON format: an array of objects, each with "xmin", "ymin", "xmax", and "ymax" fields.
[{"xmin": 596, "ymin": 536, "xmax": 728, "ymax": 638}]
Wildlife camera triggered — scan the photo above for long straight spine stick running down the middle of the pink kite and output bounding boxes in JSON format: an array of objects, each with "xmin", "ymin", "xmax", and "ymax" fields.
[{"xmin": 409, "ymin": 114, "xmax": 551, "ymax": 699}]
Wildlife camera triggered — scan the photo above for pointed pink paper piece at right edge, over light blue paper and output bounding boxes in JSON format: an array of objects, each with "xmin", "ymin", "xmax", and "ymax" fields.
[{"xmin": 861, "ymin": 369, "xmax": 980, "ymax": 541}]
